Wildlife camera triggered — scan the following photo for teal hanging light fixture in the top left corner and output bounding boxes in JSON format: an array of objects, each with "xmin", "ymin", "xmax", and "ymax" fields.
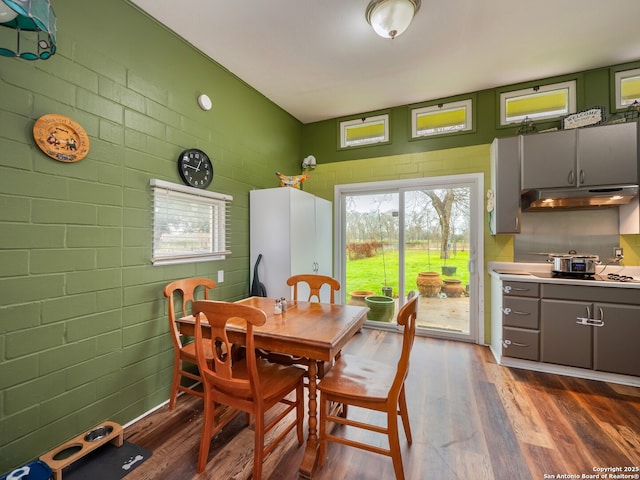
[{"xmin": 0, "ymin": 0, "xmax": 56, "ymax": 60}]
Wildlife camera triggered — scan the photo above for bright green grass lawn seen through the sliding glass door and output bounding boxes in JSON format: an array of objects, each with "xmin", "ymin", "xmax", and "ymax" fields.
[{"xmin": 345, "ymin": 249, "xmax": 469, "ymax": 300}]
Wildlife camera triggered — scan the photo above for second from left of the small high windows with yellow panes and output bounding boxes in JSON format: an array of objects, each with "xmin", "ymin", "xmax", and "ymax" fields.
[{"xmin": 411, "ymin": 99, "xmax": 473, "ymax": 138}]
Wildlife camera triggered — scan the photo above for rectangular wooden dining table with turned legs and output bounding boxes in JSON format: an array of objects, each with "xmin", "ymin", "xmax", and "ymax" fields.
[{"xmin": 176, "ymin": 297, "xmax": 369, "ymax": 478}]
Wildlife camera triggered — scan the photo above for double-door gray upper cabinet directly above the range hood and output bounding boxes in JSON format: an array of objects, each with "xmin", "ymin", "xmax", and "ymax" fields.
[{"xmin": 522, "ymin": 122, "xmax": 639, "ymax": 190}]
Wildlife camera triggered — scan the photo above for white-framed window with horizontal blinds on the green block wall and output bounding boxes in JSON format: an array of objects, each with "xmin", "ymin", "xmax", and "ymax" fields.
[{"xmin": 151, "ymin": 179, "xmax": 233, "ymax": 265}]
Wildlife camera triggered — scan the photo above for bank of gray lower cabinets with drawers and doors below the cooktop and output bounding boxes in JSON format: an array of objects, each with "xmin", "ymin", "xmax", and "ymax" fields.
[{"xmin": 492, "ymin": 280, "xmax": 640, "ymax": 377}]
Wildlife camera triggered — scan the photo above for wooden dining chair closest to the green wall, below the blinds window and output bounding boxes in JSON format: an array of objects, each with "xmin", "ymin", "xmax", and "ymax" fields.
[{"xmin": 164, "ymin": 278, "xmax": 216, "ymax": 409}]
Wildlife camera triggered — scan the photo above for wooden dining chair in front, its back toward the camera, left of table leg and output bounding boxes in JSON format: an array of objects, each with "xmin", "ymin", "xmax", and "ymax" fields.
[{"xmin": 193, "ymin": 301, "xmax": 304, "ymax": 480}]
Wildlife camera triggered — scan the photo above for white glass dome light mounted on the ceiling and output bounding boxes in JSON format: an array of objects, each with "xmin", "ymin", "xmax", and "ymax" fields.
[{"xmin": 365, "ymin": 0, "xmax": 421, "ymax": 39}]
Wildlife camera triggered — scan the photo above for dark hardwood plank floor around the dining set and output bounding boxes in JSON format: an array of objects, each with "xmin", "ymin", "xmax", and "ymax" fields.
[{"xmin": 125, "ymin": 329, "xmax": 640, "ymax": 480}]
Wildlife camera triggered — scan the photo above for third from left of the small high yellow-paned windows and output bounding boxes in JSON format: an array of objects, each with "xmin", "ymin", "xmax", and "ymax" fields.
[{"xmin": 500, "ymin": 80, "xmax": 576, "ymax": 125}]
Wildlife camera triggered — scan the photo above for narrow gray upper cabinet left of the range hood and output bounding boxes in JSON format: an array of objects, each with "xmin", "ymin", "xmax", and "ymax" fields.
[{"xmin": 489, "ymin": 136, "xmax": 521, "ymax": 234}]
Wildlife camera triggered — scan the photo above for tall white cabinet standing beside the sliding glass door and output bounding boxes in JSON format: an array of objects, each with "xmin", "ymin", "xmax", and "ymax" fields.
[{"xmin": 249, "ymin": 187, "xmax": 333, "ymax": 301}]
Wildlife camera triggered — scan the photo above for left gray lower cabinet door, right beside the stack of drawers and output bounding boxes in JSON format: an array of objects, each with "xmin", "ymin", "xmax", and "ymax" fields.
[{"xmin": 540, "ymin": 299, "xmax": 593, "ymax": 368}]
